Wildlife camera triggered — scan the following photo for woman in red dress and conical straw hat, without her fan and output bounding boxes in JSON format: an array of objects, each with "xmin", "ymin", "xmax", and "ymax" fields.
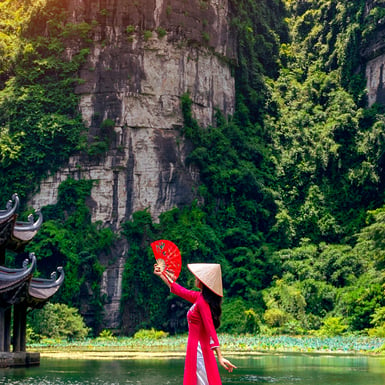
[{"xmin": 154, "ymin": 263, "xmax": 236, "ymax": 385}]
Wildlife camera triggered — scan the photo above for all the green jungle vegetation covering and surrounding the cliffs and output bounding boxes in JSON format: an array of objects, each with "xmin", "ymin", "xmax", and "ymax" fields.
[{"xmin": 0, "ymin": 0, "xmax": 385, "ymax": 337}]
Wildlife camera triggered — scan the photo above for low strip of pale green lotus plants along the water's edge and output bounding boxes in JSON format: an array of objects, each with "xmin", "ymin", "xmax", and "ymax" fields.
[{"xmin": 27, "ymin": 334, "xmax": 385, "ymax": 359}]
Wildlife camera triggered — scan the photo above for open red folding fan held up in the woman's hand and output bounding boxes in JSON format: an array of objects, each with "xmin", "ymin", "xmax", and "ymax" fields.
[{"xmin": 151, "ymin": 239, "xmax": 182, "ymax": 282}]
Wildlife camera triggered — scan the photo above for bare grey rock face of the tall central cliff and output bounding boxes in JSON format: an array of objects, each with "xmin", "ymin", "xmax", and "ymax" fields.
[{"xmin": 30, "ymin": 0, "xmax": 235, "ymax": 328}]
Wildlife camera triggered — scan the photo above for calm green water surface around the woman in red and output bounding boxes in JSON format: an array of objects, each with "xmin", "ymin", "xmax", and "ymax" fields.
[{"xmin": 0, "ymin": 354, "xmax": 385, "ymax": 385}]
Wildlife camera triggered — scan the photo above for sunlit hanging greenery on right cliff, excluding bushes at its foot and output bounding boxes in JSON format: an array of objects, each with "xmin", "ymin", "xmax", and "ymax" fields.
[{"xmin": 266, "ymin": 1, "xmax": 384, "ymax": 246}]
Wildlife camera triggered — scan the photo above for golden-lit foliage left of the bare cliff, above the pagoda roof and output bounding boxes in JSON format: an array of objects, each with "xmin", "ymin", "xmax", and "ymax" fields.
[{"xmin": 0, "ymin": 0, "xmax": 92, "ymax": 206}]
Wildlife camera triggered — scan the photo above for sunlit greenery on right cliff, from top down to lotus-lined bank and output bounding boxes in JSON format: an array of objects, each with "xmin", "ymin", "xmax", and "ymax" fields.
[{"xmin": 252, "ymin": 1, "xmax": 384, "ymax": 335}]
